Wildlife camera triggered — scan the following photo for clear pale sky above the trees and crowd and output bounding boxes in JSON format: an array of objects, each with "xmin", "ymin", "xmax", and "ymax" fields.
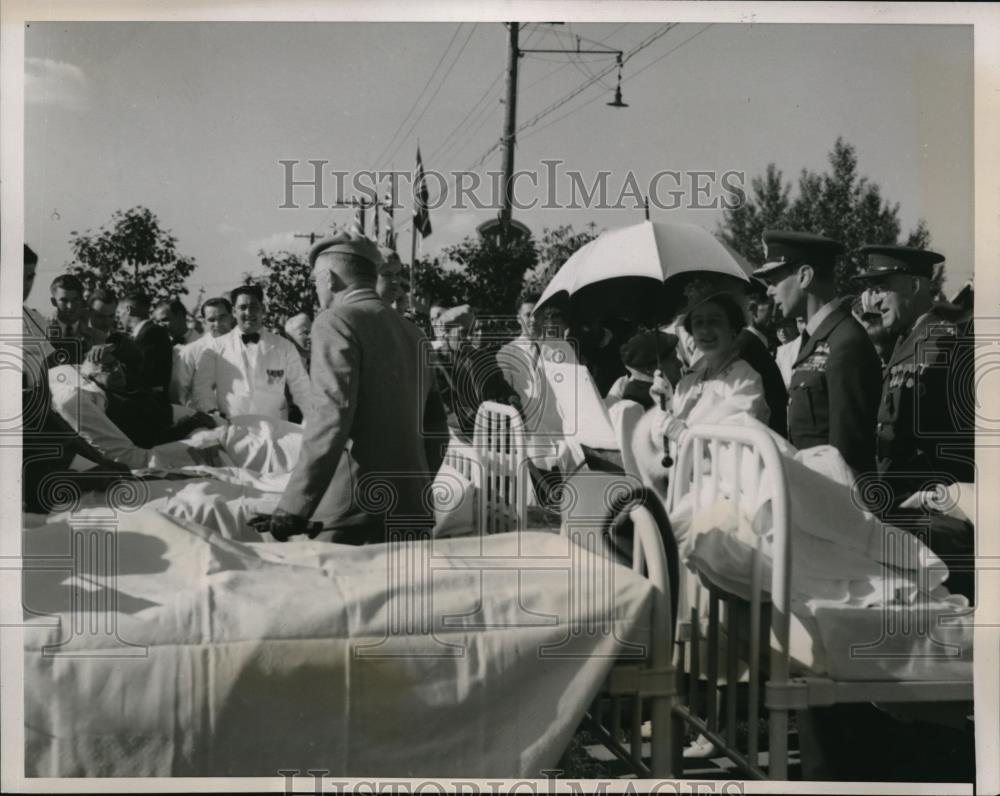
[{"xmin": 25, "ymin": 22, "xmax": 974, "ymax": 309}]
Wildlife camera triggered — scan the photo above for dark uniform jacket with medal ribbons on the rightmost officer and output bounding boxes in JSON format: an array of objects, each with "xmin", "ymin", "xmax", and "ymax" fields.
[{"xmin": 877, "ymin": 310, "xmax": 975, "ymax": 498}]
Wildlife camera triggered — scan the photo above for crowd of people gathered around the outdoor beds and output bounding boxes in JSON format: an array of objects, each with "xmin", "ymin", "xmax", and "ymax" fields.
[{"xmin": 23, "ymin": 225, "xmax": 975, "ymax": 784}]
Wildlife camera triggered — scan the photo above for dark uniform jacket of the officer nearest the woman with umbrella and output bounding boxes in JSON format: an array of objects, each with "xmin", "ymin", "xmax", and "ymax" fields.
[{"xmin": 788, "ymin": 305, "xmax": 882, "ymax": 475}]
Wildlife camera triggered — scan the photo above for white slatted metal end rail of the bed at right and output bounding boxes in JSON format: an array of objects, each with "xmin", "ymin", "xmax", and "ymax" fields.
[{"xmin": 668, "ymin": 425, "xmax": 792, "ymax": 779}]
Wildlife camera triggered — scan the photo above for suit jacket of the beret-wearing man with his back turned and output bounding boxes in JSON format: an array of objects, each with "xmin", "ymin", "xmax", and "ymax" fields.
[{"xmin": 278, "ymin": 288, "xmax": 447, "ymax": 533}]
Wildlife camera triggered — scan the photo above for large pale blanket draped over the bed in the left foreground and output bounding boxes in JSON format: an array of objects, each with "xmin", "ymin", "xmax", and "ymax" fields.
[{"xmin": 24, "ymin": 509, "xmax": 651, "ymax": 777}]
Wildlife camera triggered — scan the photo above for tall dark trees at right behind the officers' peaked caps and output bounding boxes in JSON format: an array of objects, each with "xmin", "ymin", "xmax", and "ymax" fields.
[{"xmin": 719, "ymin": 137, "xmax": 928, "ymax": 294}]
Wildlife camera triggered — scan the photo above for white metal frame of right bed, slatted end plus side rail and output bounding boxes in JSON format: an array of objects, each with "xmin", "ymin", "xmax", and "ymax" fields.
[{"xmin": 668, "ymin": 425, "xmax": 973, "ymax": 780}]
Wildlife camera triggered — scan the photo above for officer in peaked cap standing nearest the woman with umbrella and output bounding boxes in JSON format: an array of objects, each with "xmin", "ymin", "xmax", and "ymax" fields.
[{"xmin": 753, "ymin": 230, "xmax": 882, "ymax": 475}]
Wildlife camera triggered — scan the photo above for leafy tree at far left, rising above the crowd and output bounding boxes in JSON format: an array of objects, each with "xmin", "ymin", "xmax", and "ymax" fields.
[{"xmin": 67, "ymin": 207, "xmax": 197, "ymax": 301}]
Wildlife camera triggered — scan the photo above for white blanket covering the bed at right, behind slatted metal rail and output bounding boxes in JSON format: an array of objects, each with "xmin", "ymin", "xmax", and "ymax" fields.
[{"xmin": 670, "ymin": 420, "xmax": 972, "ymax": 680}]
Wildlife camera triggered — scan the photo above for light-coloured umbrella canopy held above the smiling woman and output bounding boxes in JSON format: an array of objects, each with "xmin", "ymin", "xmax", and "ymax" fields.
[{"xmin": 538, "ymin": 221, "xmax": 752, "ymax": 320}]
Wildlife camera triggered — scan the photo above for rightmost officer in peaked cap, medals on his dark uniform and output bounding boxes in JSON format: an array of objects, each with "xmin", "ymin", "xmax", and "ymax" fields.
[{"xmin": 858, "ymin": 246, "xmax": 975, "ymax": 599}]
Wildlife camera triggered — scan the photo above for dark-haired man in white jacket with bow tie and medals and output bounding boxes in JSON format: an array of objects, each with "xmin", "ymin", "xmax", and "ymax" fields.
[{"xmin": 191, "ymin": 285, "xmax": 312, "ymax": 420}]
